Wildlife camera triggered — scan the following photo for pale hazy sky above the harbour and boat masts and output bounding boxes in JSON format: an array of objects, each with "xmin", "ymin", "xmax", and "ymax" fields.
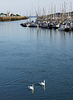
[{"xmin": 0, "ymin": 0, "xmax": 73, "ymax": 16}]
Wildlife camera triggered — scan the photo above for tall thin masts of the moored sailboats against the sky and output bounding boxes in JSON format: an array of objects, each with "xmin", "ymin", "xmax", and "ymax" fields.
[{"xmin": 29, "ymin": 2, "xmax": 72, "ymax": 19}]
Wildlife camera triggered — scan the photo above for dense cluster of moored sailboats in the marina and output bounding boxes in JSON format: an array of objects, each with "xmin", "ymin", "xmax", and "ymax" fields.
[{"xmin": 20, "ymin": 12, "xmax": 73, "ymax": 31}]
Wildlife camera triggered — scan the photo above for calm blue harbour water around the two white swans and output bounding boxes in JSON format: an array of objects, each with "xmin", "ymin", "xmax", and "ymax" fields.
[{"xmin": 0, "ymin": 21, "xmax": 73, "ymax": 100}]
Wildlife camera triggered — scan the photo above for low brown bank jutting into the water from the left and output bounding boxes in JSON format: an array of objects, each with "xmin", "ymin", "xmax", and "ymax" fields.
[{"xmin": 0, "ymin": 16, "xmax": 28, "ymax": 22}]
